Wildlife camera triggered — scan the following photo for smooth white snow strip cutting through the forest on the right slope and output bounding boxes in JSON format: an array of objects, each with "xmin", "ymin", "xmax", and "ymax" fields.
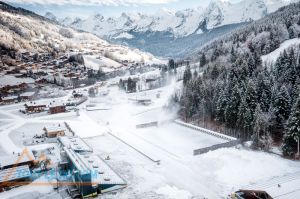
[{"xmin": 261, "ymin": 38, "xmax": 300, "ymax": 64}]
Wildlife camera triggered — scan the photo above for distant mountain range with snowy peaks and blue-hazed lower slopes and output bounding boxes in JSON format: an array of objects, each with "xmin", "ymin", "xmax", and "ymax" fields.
[{"xmin": 49, "ymin": 0, "xmax": 299, "ymax": 57}]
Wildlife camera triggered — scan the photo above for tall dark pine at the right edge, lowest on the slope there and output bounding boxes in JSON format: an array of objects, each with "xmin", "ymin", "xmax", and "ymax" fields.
[{"xmin": 282, "ymin": 97, "xmax": 300, "ymax": 156}]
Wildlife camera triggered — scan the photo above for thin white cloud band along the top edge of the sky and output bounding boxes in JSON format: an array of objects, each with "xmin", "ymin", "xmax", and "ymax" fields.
[{"xmin": 5, "ymin": 0, "xmax": 177, "ymax": 6}]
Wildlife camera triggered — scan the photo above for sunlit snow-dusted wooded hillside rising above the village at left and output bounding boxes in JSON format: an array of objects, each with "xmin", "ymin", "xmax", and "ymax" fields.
[{"xmin": 0, "ymin": 2, "xmax": 156, "ymax": 63}]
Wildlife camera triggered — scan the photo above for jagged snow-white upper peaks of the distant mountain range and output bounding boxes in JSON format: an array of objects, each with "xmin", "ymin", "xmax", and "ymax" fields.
[{"xmin": 61, "ymin": 0, "xmax": 293, "ymax": 39}]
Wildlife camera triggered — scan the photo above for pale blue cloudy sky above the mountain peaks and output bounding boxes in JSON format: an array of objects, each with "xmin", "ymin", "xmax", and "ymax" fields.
[{"xmin": 4, "ymin": 0, "xmax": 244, "ymax": 18}]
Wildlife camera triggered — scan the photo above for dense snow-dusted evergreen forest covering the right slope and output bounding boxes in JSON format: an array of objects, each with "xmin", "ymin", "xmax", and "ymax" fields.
[{"xmin": 180, "ymin": 3, "xmax": 300, "ymax": 156}]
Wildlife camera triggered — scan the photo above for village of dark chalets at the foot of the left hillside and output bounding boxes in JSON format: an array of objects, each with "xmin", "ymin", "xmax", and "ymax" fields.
[{"xmin": 0, "ymin": 44, "xmax": 162, "ymax": 104}]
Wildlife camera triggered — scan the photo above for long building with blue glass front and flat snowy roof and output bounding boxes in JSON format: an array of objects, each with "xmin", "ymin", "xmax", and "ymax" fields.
[{"xmin": 62, "ymin": 147, "xmax": 126, "ymax": 197}]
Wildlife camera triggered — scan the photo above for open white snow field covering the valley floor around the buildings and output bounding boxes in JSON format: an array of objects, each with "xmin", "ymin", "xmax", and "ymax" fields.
[{"xmin": 0, "ymin": 78, "xmax": 300, "ymax": 199}]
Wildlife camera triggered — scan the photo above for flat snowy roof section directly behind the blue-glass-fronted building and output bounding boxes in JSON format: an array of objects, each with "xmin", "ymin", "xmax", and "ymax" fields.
[{"xmin": 58, "ymin": 136, "xmax": 93, "ymax": 152}]
